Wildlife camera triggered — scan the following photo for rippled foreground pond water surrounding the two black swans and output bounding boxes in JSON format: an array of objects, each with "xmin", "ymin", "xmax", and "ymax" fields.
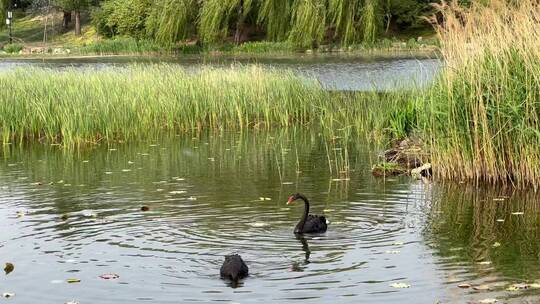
[{"xmin": 0, "ymin": 131, "xmax": 540, "ymax": 303}]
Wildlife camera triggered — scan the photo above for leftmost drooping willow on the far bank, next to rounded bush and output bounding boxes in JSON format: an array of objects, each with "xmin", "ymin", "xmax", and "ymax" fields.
[{"xmin": 146, "ymin": 0, "xmax": 198, "ymax": 45}]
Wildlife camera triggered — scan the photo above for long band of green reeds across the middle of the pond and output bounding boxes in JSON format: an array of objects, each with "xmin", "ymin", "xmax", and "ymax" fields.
[{"xmin": 0, "ymin": 65, "xmax": 404, "ymax": 146}]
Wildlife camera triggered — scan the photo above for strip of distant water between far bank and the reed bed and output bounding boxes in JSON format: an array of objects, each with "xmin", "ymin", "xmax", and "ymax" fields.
[{"xmin": 0, "ymin": 55, "xmax": 441, "ymax": 91}]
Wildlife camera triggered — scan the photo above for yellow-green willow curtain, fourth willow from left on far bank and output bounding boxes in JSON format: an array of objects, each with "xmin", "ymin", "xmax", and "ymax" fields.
[{"xmin": 289, "ymin": 0, "xmax": 326, "ymax": 47}]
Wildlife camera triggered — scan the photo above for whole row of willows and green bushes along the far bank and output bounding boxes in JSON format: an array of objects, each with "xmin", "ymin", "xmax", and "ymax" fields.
[{"xmin": 93, "ymin": 0, "xmax": 433, "ymax": 48}]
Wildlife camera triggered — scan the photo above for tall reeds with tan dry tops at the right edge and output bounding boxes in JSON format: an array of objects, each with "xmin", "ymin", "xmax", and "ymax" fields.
[{"xmin": 418, "ymin": 0, "xmax": 540, "ymax": 189}]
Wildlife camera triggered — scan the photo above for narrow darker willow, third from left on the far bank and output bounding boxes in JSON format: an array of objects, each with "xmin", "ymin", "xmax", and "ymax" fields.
[{"xmin": 257, "ymin": 0, "xmax": 293, "ymax": 41}]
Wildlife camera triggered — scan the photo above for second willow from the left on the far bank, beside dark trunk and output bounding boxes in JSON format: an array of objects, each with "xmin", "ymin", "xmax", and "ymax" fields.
[{"xmin": 199, "ymin": 0, "xmax": 253, "ymax": 43}]
